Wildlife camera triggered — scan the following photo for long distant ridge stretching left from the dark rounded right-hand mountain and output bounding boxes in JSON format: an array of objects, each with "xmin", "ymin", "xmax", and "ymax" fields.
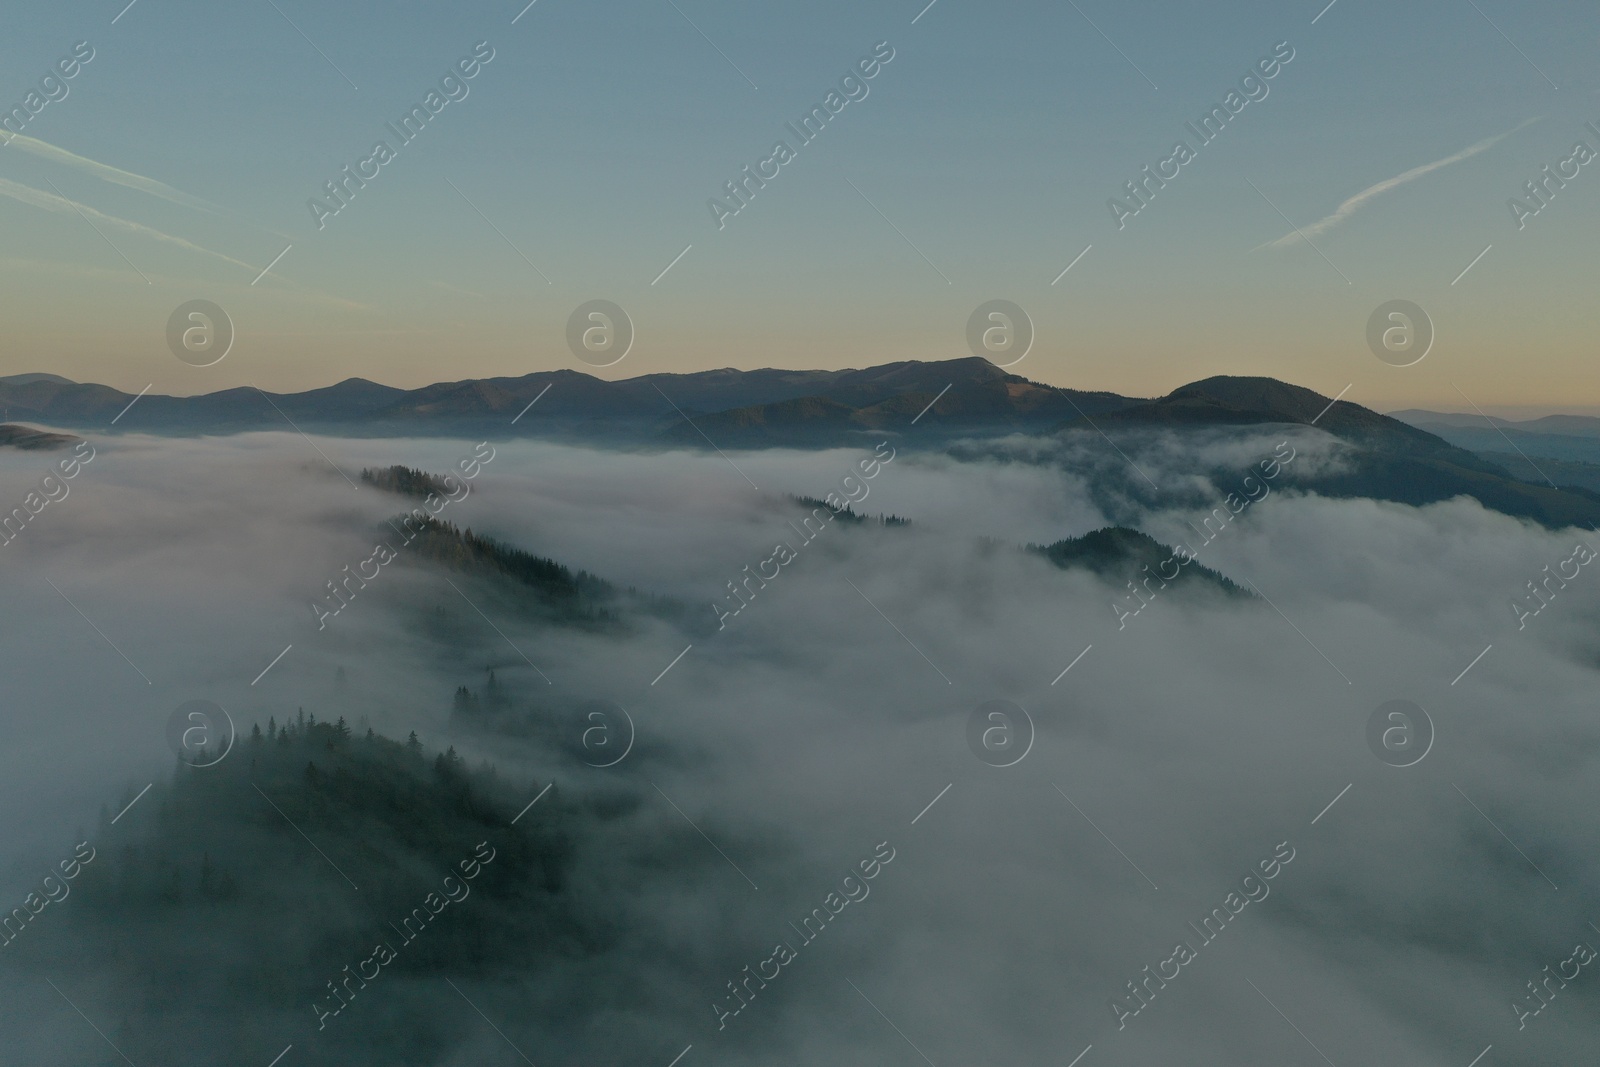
[{"xmin": 0, "ymin": 357, "xmax": 1136, "ymax": 448}]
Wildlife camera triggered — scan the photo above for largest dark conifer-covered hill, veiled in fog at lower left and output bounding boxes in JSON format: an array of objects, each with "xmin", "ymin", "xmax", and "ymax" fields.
[{"xmin": 10, "ymin": 717, "xmax": 588, "ymax": 1064}]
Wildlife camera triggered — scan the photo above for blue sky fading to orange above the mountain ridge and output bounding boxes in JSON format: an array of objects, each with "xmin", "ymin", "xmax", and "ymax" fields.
[{"xmin": 0, "ymin": 0, "xmax": 1600, "ymax": 416}]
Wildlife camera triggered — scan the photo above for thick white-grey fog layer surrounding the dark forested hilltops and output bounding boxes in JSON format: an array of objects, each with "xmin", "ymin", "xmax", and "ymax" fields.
[{"xmin": 0, "ymin": 427, "xmax": 1600, "ymax": 1067}]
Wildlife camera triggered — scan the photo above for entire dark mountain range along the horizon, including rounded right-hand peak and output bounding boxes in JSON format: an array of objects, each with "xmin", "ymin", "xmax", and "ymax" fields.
[{"xmin": 9, "ymin": 358, "xmax": 1600, "ymax": 526}]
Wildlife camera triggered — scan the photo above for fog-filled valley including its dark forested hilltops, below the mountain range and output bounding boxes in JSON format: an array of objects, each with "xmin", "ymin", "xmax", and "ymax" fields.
[{"xmin": 0, "ymin": 424, "xmax": 1600, "ymax": 1067}]
